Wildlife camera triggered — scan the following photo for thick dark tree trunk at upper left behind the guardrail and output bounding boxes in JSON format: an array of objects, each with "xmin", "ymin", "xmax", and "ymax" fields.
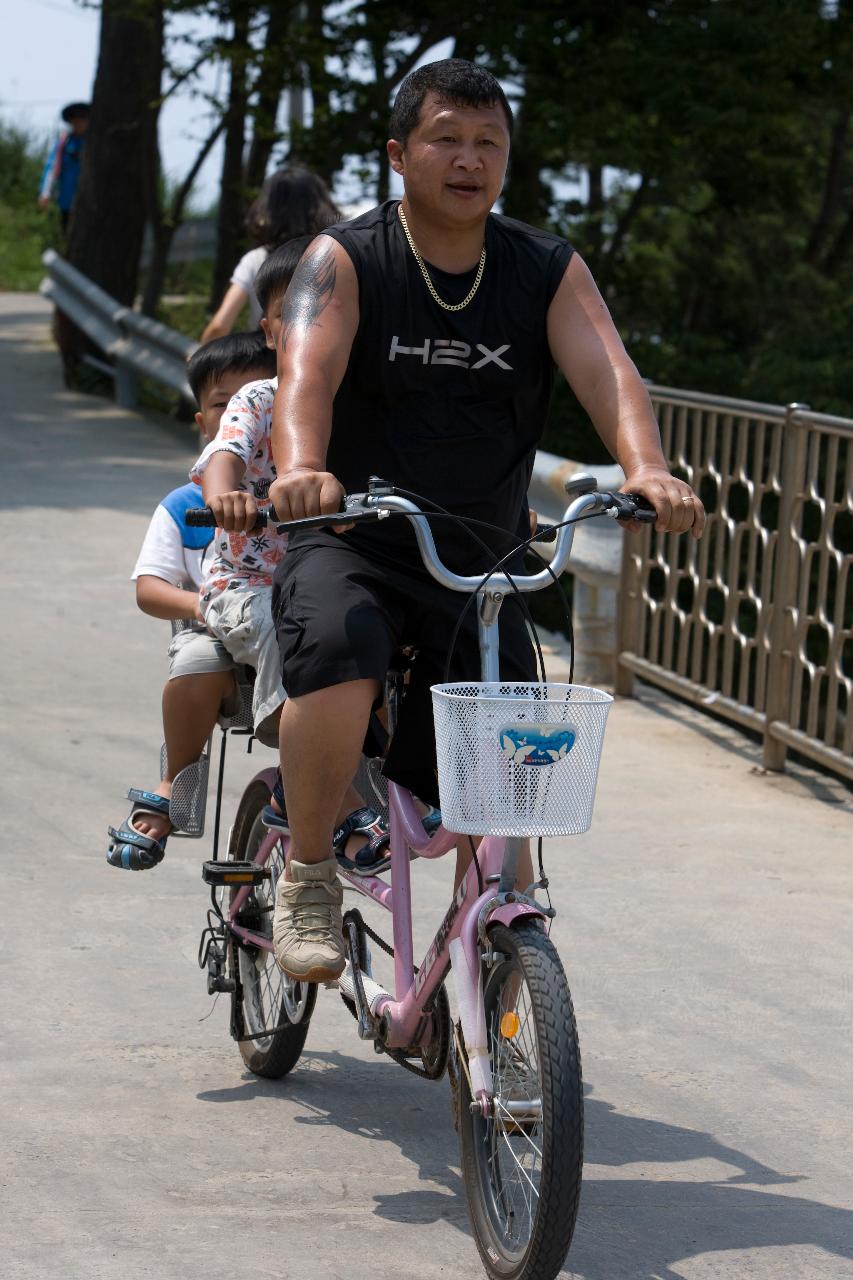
[{"xmin": 68, "ymin": 0, "xmax": 163, "ymax": 306}]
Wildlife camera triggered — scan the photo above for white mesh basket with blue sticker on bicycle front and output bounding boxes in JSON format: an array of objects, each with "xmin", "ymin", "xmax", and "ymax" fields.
[{"xmin": 432, "ymin": 681, "xmax": 613, "ymax": 836}]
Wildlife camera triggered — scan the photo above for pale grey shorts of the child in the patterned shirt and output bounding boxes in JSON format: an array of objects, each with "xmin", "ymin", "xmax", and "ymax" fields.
[{"xmin": 205, "ymin": 586, "xmax": 287, "ymax": 746}]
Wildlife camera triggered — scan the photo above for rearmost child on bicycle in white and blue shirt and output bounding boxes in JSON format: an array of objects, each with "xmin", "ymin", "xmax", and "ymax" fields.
[{"xmin": 106, "ymin": 329, "xmax": 275, "ymax": 870}]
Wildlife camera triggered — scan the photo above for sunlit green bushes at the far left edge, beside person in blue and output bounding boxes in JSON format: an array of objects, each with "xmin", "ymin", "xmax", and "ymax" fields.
[{"xmin": 0, "ymin": 120, "xmax": 61, "ymax": 289}]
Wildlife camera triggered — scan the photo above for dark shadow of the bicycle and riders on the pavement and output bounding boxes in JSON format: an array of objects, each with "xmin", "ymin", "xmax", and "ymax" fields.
[{"xmin": 199, "ymin": 1052, "xmax": 853, "ymax": 1280}]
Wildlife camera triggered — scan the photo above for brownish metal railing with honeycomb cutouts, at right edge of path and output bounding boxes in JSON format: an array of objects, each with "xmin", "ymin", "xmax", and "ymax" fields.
[{"xmin": 616, "ymin": 387, "xmax": 853, "ymax": 780}]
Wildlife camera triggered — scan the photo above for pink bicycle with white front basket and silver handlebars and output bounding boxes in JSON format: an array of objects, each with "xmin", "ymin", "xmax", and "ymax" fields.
[{"xmin": 188, "ymin": 477, "xmax": 654, "ymax": 1280}]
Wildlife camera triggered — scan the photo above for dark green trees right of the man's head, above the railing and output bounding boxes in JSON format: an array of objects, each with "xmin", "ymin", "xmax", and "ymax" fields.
[{"xmin": 480, "ymin": 0, "xmax": 853, "ymax": 427}]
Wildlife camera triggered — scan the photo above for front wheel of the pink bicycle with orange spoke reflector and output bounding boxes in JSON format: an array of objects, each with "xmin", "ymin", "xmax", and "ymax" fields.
[{"xmin": 459, "ymin": 922, "xmax": 583, "ymax": 1280}]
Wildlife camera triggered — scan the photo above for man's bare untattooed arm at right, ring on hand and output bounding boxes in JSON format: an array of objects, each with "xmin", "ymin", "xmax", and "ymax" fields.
[{"xmin": 548, "ymin": 253, "xmax": 704, "ymax": 538}]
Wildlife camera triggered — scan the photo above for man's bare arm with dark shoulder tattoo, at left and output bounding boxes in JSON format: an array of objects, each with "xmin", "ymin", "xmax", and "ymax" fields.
[{"xmin": 269, "ymin": 236, "xmax": 359, "ymax": 520}]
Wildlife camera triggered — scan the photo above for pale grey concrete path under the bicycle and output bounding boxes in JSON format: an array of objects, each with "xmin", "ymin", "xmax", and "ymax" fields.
[{"xmin": 0, "ymin": 296, "xmax": 853, "ymax": 1280}]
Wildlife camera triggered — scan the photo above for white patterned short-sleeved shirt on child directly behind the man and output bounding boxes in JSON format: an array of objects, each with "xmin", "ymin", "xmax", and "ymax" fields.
[{"xmin": 190, "ymin": 378, "xmax": 287, "ymax": 609}]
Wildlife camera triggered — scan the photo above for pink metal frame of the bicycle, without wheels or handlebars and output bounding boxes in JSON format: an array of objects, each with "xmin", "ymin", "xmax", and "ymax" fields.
[{"xmin": 227, "ymin": 769, "xmax": 544, "ymax": 1110}]
